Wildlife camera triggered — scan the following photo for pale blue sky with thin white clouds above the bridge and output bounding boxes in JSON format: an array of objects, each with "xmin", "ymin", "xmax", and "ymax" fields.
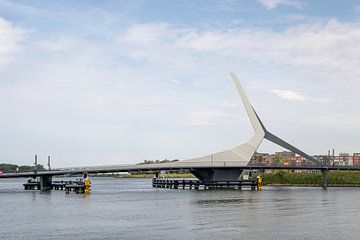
[{"xmin": 0, "ymin": 0, "xmax": 360, "ymax": 167}]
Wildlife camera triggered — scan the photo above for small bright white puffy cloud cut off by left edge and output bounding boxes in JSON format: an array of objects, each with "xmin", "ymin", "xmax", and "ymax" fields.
[{"xmin": 0, "ymin": 17, "xmax": 25, "ymax": 63}]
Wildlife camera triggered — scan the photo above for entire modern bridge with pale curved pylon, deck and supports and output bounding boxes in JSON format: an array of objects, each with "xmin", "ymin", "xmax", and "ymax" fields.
[{"xmin": 0, "ymin": 73, "xmax": 354, "ymax": 189}]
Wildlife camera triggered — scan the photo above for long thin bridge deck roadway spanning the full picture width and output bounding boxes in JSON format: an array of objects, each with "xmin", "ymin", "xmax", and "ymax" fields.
[{"xmin": 0, "ymin": 163, "xmax": 360, "ymax": 178}]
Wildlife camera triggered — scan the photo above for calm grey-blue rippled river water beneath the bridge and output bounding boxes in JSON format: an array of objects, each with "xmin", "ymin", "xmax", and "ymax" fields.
[{"xmin": 0, "ymin": 178, "xmax": 360, "ymax": 240}]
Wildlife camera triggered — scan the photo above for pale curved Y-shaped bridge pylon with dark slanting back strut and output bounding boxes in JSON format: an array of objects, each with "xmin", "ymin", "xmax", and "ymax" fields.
[{"xmin": 179, "ymin": 72, "xmax": 320, "ymax": 167}]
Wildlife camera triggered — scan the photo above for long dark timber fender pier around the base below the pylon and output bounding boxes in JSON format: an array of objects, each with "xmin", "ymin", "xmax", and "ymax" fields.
[{"xmin": 152, "ymin": 178, "xmax": 262, "ymax": 191}]
